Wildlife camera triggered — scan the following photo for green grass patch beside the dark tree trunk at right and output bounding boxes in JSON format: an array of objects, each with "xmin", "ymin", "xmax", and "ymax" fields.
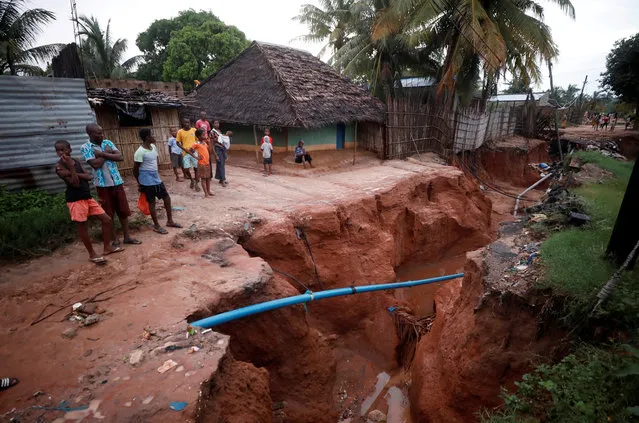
[{"xmin": 541, "ymin": 152, "xmax": 639, "ymax": 326}]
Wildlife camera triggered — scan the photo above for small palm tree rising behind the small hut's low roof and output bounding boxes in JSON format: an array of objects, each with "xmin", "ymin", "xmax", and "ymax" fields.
[{"xmin": 78, "ymin": 16, "xmax": 141, "ymax": 79}]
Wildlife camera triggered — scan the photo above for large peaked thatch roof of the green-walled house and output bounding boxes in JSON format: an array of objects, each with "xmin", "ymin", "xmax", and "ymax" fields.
[{"xmin": 186, "ymin": 42, "xmax": 385, "ymax": 127}]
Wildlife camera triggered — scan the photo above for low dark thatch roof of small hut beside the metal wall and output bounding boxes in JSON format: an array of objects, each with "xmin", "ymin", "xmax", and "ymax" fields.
[{"xmin": 87, "ymin": 88, "xmax": 182, "ymax": 109}]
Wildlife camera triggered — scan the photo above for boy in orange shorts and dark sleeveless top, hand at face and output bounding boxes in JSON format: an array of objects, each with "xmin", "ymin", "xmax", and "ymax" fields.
[{"xmin": 55, "ymin": 140, "xmax": 124, "ymax": 264}]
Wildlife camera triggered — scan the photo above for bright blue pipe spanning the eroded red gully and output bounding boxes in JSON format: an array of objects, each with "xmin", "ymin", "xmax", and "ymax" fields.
[{"xmin": 191, "ymin": 273, "xmax": 464, "ymax": 328}]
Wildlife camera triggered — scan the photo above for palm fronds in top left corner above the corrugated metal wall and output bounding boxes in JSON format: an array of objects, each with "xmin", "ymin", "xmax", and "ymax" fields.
[{"xmin": 0, "ymin": 0, "xmax": 64, "ymax": 75}]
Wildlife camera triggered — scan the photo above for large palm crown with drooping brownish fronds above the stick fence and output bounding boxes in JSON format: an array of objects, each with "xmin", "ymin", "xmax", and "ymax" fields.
[{"xmin": 378, "ymin": 0, "xmax": 575, "ymax": 102}]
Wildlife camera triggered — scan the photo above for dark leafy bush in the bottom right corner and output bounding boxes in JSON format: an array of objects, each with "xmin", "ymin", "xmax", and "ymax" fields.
[{"xmin": 481, "ymin": 346, "xmax": 639, "ymax": 423}]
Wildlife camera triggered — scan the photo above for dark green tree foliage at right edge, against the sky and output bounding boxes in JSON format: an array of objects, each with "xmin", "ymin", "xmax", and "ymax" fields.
[{"xmin": 601, "ymin": 33, "xmax": 639, "ymax": 113}]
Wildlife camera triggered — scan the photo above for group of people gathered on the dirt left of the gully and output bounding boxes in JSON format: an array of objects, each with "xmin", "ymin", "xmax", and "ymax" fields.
[{"xmin": 55, "ymin": 112, "xmax": 313, "ymax": 264}]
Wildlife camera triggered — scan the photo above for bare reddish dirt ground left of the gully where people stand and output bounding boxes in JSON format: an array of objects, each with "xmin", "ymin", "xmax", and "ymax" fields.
[{"xmin": 0, "ymin": 161, "xmax": 470, "ymax": 421}]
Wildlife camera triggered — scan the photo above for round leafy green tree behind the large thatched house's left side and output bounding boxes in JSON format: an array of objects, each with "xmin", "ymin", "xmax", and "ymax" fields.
[{"xmin": 136, "ymin": 10, "xmax": 249, "ymax": 90}]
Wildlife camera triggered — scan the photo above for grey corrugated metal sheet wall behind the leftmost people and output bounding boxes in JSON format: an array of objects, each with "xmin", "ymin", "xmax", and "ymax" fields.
[{"xmin": 0, "ymin": 76, "xmax": 95, "ymax": 192}]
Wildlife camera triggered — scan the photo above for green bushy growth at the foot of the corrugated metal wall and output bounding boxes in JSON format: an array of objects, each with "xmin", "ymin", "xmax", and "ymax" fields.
[{"xmin": 0, "ymin": 188, "xmax": 75, "ymax": 259}]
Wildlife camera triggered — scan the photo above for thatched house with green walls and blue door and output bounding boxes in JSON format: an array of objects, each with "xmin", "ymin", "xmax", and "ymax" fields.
[{"xmin": 182, "ymin": 42, "xmax": 386, "ymax": 150}]
